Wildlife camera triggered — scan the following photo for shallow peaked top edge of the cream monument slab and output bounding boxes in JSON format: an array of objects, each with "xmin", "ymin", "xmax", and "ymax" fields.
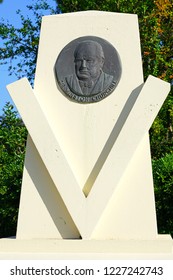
[{"xmin": 43, "ymin": 10, "xmax": 138, "ymax": 19}]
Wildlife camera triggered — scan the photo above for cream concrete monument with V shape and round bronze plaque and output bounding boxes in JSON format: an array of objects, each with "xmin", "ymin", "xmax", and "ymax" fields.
[{"xmin": 0, "ymin": 11, "xmax": 172, "ymax": 258}]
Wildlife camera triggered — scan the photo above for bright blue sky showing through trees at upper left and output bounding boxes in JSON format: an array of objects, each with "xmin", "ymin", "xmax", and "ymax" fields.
[{"xmin": 0, "ymin": 0, "xmax": 55, "ymax": 115}]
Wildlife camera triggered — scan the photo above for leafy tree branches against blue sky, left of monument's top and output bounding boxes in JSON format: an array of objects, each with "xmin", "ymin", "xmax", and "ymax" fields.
[{"xmin": 0, "ymin": 0, "xmax": 56, "ymax": 83}]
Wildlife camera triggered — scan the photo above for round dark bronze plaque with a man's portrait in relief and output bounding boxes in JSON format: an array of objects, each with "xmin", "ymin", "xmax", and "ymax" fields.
[{"xmin": 55, "ymin": 36, "xmax": 121, "ymax": 103}]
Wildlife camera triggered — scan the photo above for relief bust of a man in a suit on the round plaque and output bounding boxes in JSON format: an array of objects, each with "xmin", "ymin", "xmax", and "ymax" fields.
[{"xmin": 65, "ymin": 40, "xmax": 113, "ymax": 96}]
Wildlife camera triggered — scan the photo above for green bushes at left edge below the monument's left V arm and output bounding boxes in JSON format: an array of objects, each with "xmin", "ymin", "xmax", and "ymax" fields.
[{"xmin": 0, "ymin": 103, "xmax": 27, "ymax": 237}]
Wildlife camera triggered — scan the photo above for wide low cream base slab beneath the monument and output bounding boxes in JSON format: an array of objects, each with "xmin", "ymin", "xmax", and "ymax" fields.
[{"xmin": 0, "ymin": 235, "xmax": 173, "ymax": 260}]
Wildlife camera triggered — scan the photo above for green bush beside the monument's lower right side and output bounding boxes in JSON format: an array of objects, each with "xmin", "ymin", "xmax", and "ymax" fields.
[{"xmin": 153, "ymin": 154, "xmax": 173, "ymax": 237}]
